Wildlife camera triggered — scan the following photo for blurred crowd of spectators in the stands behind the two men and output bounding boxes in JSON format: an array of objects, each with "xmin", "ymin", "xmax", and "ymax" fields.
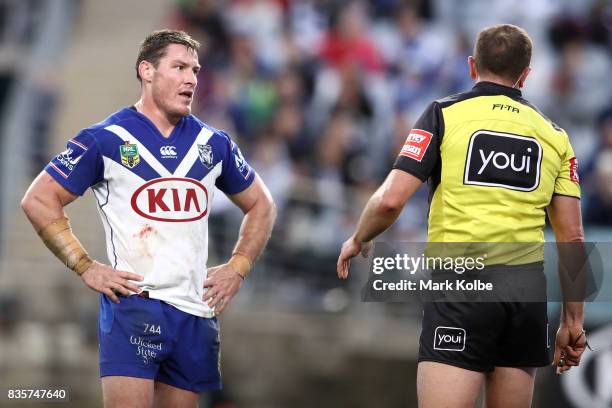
[{"xmin": 0, "ymin": 0, "xmax": 612, "ymax": 302}]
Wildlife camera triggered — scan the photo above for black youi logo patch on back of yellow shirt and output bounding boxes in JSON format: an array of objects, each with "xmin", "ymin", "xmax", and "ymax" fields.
[{"xmin": 463, "ymin": 130, "xmax": 542, "ymax": 191}]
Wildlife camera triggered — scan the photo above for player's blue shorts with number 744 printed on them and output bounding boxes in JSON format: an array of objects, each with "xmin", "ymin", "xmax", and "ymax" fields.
[{"xmin": 98, "ymin": 295, "xmax": 221, "ymax": 392}]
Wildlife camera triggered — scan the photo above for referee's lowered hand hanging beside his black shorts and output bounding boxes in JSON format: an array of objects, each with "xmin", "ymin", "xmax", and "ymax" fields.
[{"xmin": 552, "ymin": 324, "xmax": 588, "ymax": 374}]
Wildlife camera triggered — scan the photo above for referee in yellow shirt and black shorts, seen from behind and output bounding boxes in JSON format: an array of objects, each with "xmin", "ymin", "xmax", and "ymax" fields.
[{"xmin": 337, "ymin": 24, "xmax": 586, "ymax": 408}]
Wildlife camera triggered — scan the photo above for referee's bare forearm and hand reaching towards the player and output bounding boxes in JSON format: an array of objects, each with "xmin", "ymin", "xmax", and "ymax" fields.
[{"xmin": 336, "ymin": 169, "xmax": 423, "ymax": 279}]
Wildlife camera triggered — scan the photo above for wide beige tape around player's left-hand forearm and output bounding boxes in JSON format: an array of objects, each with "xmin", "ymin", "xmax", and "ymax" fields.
[{"xmin": 38, "ymin": 217, "xmax": 93, "ymax": 275}]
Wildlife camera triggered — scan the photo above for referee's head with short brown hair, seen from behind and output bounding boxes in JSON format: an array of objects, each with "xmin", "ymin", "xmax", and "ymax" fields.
[{"xmin": 474, "ymin": 24, "xmax": 533, "ymax": 81}]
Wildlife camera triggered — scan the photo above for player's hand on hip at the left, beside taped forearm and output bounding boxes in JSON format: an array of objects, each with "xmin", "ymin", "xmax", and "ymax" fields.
[{"xmin": 81, "ymin": 261, "xmax": 144, "ymax": 303}]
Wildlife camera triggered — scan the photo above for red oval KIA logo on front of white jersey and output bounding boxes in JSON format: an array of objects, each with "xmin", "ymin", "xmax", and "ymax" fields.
[{"xmin": 131, "ymin": 177, "xmax": 208, "ymax": 222}]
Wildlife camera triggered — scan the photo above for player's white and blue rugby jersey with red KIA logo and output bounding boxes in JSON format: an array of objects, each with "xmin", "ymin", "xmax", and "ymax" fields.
[{"xmin": 45, "ymin": 107, "xmax": 255, "ymax": 317}]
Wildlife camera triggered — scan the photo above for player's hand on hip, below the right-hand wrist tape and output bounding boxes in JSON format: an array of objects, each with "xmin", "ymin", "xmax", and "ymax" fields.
[{"xmin": 202, "ymin": 264, "xmax": 242, "ymax": 315}]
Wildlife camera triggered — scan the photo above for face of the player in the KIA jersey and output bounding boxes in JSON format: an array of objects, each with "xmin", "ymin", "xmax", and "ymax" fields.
[{"xmin": 151, "ymin": 44, "xmax": 200, "ymax": 117}]
